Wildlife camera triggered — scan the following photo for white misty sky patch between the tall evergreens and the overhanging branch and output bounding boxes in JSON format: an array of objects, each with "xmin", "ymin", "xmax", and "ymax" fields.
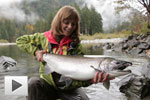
[{"xmin": 85, "ymin": 0, "xmax": 129, "ymax": 30}]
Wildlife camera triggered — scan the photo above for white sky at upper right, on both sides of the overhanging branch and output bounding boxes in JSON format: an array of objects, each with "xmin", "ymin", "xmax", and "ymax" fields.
[{"xmin": 85, "ymin": 0, "xmax": 146, "ymax": 30}]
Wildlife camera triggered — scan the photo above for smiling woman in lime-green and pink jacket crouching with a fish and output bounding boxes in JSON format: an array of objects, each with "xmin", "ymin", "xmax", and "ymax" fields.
[{"xmin": 16, "ymin": 6, "xmax": 111, "ymax": 100}]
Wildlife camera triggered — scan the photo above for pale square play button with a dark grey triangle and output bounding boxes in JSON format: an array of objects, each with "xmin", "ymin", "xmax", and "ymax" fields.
[{"xmin": 5, "ymin": 76, "xmax": 28, "ymax": 96}]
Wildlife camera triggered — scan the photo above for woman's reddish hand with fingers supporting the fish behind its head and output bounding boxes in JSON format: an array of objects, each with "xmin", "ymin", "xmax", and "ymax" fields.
[{"xmin": 92, "ymin": 72, "xmax": 114, "ymax": 83}]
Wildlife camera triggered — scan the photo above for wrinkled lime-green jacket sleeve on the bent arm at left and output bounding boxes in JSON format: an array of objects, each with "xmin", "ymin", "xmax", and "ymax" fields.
[{"xmin": 16, "ymin": 33, "xmax": 44, "ymax": 55}]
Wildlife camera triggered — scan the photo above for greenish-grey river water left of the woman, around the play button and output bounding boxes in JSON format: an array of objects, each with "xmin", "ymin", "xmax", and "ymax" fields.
[{"xmin": 0, "ymin": 45, "xmax": 39, "ymax": 100}]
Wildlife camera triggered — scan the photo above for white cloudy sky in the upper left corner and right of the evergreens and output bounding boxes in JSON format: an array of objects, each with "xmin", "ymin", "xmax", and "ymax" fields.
[{"xmin": 0, "ymin": 0, "xmax": 144, "ymax": 30}]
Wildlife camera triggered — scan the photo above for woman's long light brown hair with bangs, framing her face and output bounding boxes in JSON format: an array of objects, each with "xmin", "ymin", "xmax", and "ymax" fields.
[{"xmin": 51, "ymin": 6, "xmax": 80, "ymax": 42}]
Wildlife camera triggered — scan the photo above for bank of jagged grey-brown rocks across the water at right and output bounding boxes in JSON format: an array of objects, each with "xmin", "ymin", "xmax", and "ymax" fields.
[{"xmin": 103, "ymin": 33, "xmax": 150, "ymax": 57}]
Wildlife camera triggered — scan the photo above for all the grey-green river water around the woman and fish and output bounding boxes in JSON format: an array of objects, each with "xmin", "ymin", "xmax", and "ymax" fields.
[{"xmin": 0, "ymin": 45, "xmax": 150, "ymax": 100}]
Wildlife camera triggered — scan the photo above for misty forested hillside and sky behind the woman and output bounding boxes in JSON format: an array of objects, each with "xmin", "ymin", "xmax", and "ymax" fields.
[{"xmin": 0, "ymin": 0, "xmax": 147, "ymax": 42}]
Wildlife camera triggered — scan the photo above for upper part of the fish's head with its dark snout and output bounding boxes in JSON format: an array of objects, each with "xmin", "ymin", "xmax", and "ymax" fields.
[{"xmin": 101, "ymin": 58, "xmax": 132, "ymax": 72}]
